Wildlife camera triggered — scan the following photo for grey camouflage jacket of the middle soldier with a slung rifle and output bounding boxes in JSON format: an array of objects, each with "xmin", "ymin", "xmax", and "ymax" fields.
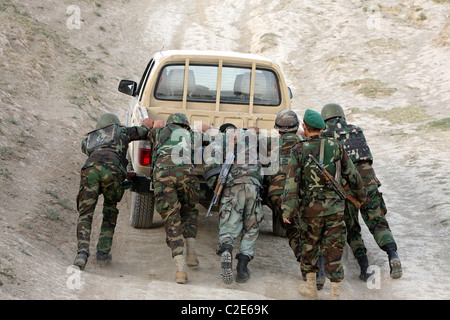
[{"xmin": 204, "ymin": 130, "xmax": 262, "ymax": 187}]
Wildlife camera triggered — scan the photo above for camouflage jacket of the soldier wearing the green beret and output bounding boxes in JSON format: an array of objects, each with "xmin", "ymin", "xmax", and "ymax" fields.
[{"xmin": 281, "ymin": 135, "xmax": 365, "ymax": 219}]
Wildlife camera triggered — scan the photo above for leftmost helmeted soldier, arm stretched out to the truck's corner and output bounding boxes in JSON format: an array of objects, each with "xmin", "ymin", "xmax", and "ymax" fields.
[{"xmin": 74, "ymin": 113, "xmax": 153, "ymax": 270}]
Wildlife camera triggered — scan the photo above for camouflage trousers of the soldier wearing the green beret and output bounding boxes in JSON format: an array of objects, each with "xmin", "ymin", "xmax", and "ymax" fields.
[{"xmin": 300, "ymin": 203, "xmax": 345, "ymax": 282}]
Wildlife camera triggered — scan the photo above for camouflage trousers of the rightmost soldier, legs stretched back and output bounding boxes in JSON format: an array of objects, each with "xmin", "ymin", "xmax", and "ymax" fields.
[{"xmin": 344, "ymin": 185, "xmax": 397, "ymax": 258}]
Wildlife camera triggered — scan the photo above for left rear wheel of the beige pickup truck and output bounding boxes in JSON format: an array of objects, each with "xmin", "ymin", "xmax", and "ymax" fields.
[{"xmin": 130, "ymin": 192, "xmax": 155, "ymax": 229}]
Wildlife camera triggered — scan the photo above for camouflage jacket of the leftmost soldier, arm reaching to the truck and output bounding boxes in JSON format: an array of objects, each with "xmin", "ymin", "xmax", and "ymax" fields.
[{"xmin": 81, "ymin": 125, "xmax": 149, "ymax": 173}]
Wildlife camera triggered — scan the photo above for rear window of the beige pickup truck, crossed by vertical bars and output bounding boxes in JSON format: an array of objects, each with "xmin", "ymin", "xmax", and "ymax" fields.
[{"xmin": 155, "ymin": 64, "xmax": 281, "ymax": 106}]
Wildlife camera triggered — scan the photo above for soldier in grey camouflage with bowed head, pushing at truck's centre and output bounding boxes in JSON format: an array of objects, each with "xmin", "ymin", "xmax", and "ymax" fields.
[{"xmin": 210, "ymin": 126, "xmax": 264, "ymax": 284}]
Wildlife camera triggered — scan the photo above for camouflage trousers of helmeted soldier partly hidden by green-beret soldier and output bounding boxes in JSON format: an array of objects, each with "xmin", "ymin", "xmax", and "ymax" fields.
[{"xmin": 268, "ymin": 194, "xmax": 304, "ymax": 262}]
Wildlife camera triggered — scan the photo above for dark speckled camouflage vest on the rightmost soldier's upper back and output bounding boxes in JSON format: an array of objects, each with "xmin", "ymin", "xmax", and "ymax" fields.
[{"xmin": 322, "ymin": 118, "xmax": 373, "ymax": 164}]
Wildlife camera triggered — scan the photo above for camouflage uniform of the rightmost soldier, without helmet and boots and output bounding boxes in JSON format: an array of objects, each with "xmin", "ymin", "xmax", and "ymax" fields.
[{"xmin": 322, "ymin": 117, "xmax": 397, "ymax": 259}]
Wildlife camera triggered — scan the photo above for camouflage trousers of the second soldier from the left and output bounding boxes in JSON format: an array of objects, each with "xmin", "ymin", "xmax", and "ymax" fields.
[{"xmin": 153, "ymin": 168, "xmax": 200, "ymax": 257}]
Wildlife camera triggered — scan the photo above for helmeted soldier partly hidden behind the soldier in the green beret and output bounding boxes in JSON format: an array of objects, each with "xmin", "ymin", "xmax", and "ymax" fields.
[{"xmin": 267, "ymin": 110, "xmax": 326, "ymax": 290}]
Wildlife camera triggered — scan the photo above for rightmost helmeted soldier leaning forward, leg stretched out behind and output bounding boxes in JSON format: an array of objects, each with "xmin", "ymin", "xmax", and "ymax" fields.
[{"xmin": 322, "ymin": 103, "xmax": 402, "ymax": 281}]
